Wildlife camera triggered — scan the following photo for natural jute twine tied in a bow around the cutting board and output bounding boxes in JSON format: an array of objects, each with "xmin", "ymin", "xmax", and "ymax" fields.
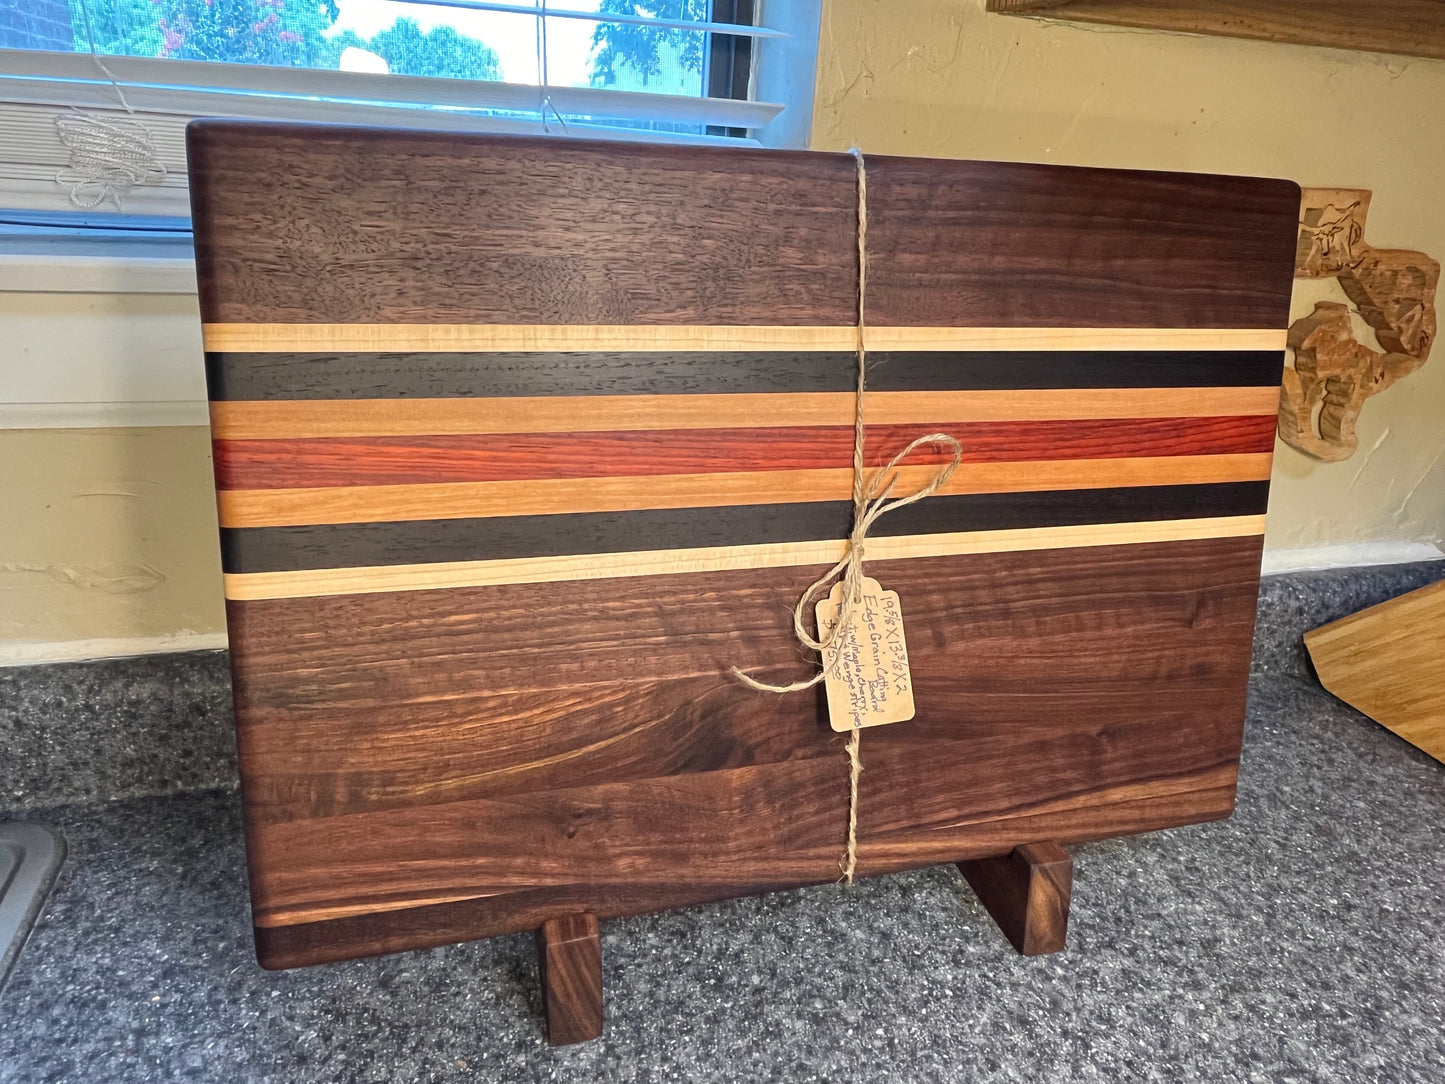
[{"xmin": 733, "ymin": 149, "xmax": 964, "ymax": 885}]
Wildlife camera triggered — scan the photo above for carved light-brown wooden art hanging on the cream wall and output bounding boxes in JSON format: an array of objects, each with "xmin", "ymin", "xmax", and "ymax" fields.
[{"xmin": 1279, "ymin": 188, "xmax": 1441, "ymax": 463}]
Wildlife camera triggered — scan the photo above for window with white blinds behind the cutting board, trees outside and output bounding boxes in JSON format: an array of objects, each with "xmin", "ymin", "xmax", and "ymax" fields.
[{"xmin": 0, "ymin": 0, "xmax": 821, "ymax": 221}]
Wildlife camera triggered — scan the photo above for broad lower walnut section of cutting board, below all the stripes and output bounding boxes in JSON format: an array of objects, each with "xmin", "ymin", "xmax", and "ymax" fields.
[{"xmin": 231, "ymin": 538, "xmax": 1259, "ymax": 948}]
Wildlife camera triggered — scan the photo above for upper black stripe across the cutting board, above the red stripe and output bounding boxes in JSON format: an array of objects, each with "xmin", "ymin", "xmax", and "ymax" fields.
[{"xmin": 205, "ymin": 350, "xmax": 1285, "ymax": 400}]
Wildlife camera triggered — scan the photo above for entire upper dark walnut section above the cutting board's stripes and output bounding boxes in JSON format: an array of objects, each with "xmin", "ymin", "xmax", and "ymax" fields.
[{"xmin": 186, "ymin": 121, "xmax": 1299, "ymax": 329}]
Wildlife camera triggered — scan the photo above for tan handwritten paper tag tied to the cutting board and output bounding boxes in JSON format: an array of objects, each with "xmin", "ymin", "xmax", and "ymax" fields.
[{"xmin": 816, "ymin": 577, "xmax": 913, "ymax": 733}]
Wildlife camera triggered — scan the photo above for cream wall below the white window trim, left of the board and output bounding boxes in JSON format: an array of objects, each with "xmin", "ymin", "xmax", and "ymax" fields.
[{"xmin": 0, "ymin": 426, "xmax": 225, "ymax": 663}]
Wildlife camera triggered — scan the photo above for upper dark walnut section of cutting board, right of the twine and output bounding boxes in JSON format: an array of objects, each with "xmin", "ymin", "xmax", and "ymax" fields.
[{"xmin": 867, "ymin": 156, "xmax": 1299, "ymax": 328}]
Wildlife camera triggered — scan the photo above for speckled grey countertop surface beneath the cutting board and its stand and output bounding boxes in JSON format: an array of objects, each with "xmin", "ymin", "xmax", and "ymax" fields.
[{"xmin": 0, "ymin": 675, "xmax": 1445, "ymax": 1084}]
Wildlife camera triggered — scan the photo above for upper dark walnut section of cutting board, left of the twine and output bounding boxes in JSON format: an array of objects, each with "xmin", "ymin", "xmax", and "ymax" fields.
[{"xmin": 186, "ymin": 121, "xmax": 858, "ymax": 326}]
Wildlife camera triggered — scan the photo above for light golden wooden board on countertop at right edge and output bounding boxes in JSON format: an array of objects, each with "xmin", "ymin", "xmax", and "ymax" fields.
[{"xmin": 1305, "ymin": 581, "xmax": 1445, "ymax": 763}]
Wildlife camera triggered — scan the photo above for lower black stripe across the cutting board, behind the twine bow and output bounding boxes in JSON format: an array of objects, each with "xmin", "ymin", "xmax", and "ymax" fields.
[{"xmin": 221, "ymin": 481, "xmax": 1269, "ymax": 572}]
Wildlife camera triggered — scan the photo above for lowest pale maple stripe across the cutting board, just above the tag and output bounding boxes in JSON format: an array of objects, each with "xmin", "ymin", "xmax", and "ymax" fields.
[{"xmin": 224, "ymin": 516, "xmax": 1264, "ymax": 601}]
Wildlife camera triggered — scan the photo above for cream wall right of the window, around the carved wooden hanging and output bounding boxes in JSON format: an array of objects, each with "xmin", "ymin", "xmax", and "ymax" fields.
[{"xmin": 812, "ymin": 0, "xmax": 1445, "ymax": 551}]
